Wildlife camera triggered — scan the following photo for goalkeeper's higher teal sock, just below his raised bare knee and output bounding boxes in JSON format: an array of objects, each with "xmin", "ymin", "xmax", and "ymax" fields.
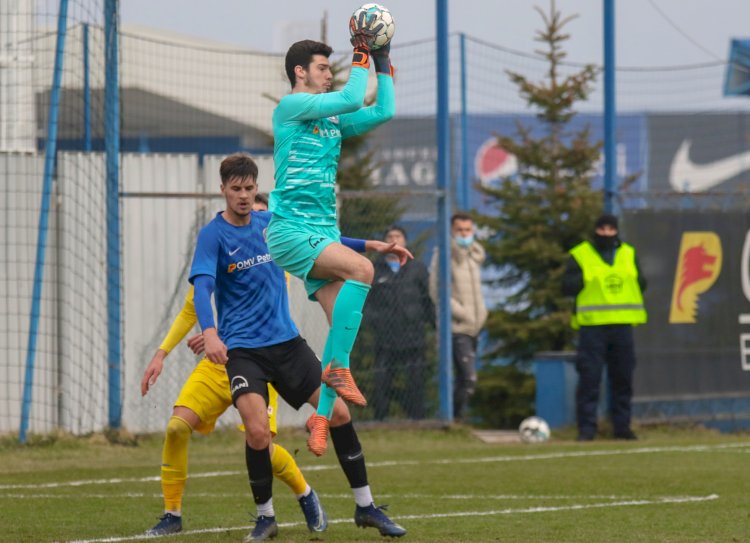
[{"xmin": 323, "ymin": 280, "xmax": 370, "ymax": 368}]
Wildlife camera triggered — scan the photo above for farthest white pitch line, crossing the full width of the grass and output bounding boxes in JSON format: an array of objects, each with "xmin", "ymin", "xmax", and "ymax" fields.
[{"xmin": 0, "ymin": 442, "xmax": 750, "ymax": 490}]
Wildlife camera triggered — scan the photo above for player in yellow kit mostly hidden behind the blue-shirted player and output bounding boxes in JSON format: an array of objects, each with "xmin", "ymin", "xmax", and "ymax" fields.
[{"xmin": 141, "ymin": 199, "xmax": 328, "ymax": 535}]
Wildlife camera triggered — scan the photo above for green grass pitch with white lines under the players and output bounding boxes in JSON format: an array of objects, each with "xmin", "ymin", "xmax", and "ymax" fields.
[{"xmin": 0, "ymin": 428, "xmax": 750, "ymax": 543}]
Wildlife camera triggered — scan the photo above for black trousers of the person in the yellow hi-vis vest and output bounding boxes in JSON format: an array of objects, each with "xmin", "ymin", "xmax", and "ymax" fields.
[{"xmin": 576, "ymin": 324, "xmax": 635, "ymax": 435}]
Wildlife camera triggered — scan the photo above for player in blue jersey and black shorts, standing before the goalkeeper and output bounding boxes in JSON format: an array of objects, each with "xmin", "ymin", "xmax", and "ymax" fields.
[{"xmin": 190, "ymin": 154, "xmax": 411, "ymax": 541}]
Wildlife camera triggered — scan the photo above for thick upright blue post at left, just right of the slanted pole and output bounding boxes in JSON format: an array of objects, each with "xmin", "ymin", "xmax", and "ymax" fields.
[{"xmin": 104, "ymin": 0, "xmax": 122, "ymax": 428}]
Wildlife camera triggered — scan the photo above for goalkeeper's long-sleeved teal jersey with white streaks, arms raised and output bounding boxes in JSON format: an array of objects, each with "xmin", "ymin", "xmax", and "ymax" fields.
[{"xmin": 269, "ymin": 67, "xmax": 395, "ymax": 226}]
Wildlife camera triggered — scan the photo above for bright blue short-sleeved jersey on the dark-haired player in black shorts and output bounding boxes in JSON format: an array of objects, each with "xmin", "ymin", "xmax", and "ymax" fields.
[{"xmin": 190, "ymin": 211, "xmax": 299, "ymax": 349}]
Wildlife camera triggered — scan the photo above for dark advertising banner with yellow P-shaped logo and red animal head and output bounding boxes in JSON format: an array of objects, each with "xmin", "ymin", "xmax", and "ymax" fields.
[{"xmin": 623, "ymin": 210, "xmax": 750, "ymax": 399}]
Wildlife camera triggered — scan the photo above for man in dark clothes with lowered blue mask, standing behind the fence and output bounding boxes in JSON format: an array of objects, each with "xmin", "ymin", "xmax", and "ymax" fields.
[{"xmin": 365, "ymin": 226, "xmax": 435, "ymax": 420}]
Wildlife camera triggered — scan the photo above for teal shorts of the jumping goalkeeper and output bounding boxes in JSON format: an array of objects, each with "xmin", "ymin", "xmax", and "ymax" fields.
[{"xmin": 266, "ymin": 215, "xmax": 341, "ymax": 300}]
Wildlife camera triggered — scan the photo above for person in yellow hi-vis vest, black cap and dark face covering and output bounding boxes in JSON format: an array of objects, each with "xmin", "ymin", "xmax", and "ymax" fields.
[{"xmin": 563, "ymin": 215, "xmax": 647, "ymax": 441}]
